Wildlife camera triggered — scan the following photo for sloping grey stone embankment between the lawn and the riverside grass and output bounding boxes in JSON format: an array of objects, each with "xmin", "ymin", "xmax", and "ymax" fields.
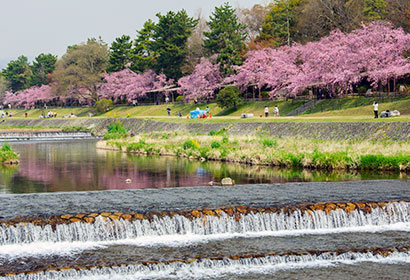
[{"xmin": 0, "ymin": 118, "xmax": 410, "ymax": 140}]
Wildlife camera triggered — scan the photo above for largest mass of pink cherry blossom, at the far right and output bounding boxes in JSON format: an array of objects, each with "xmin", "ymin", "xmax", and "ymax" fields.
[{"xmin": 229, "ymin": 22, "xmax": 410, "ymax": 97}]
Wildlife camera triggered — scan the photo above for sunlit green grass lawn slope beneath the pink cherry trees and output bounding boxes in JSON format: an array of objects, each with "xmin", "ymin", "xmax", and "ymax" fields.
[{"xmin": 3, "ymin": 97, "xmax": 410, "ymax": 122}]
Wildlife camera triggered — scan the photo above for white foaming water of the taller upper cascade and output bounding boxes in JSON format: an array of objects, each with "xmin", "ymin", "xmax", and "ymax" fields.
[{"xmin": 0, "ymin": 202, "xmax": 410, "ymax": 257}]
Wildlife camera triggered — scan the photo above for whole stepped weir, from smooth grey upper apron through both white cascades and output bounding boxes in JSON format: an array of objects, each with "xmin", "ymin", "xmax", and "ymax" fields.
[{"xmin": 0, "ymin": 174, "xmax": 410, "ymax": 280}]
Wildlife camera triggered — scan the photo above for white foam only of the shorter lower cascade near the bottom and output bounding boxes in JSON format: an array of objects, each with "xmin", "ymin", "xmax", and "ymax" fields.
[{"xmin": 0, "ymin": 252, "xmax": 410, "ymax": 280}]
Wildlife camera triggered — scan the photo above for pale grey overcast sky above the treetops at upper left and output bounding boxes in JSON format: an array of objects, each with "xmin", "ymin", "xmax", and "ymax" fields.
[{"xmin": 0, "ymin": 0, "xmax": 266, "ymax": 69}]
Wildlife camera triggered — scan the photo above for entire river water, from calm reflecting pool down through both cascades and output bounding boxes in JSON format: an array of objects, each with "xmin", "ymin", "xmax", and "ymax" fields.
[{"xmin": 0, "ymin": 141, "xmax": 410, "ymax": 280}]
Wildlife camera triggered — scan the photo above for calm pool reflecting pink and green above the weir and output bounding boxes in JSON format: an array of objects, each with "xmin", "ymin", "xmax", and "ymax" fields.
[{"xmin": 0, "ymin": 141, "xmax": 410, "ymax": 193}]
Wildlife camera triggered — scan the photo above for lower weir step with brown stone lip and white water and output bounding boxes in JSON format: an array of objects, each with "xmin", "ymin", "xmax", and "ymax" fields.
[{"xmin": 0, "ymin": 247, "xmax": 410, "ymax": 280}]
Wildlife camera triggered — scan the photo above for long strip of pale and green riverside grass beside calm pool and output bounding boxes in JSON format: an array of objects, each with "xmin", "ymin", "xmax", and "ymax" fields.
[{"xmin": 97, "ymin": 131, "xmax": 410, "ymax": 172}]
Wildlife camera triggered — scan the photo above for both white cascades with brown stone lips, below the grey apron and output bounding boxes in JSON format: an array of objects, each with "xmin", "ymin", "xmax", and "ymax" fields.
[{"xmin": 0, "ymin": 200, "xmax": 410, "ymax": 280}]
